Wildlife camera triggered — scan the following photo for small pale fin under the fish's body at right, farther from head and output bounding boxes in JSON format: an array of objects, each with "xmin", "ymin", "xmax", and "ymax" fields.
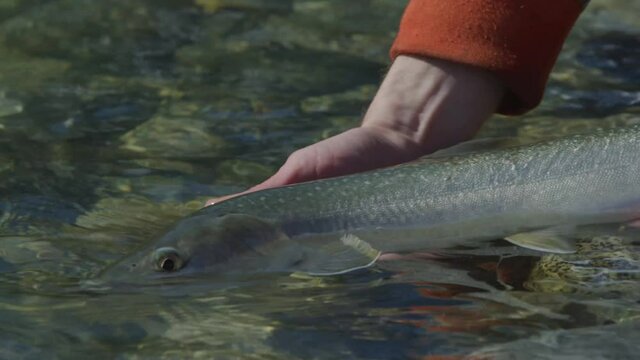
[{"xmin": 505, "ymin": 227, "xmax": 576, "ymax": 254}]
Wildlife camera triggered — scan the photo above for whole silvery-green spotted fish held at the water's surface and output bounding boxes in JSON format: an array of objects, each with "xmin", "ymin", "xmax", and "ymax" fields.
[{"xmin": 106, "ymin": 126, "xmax": 640, "ymax": 281}]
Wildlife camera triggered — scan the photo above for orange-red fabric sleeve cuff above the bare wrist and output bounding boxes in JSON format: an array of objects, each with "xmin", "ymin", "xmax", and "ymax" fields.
[{"xmin": 391, "ymin": 0, "xmax": 582, "ymax": 114}]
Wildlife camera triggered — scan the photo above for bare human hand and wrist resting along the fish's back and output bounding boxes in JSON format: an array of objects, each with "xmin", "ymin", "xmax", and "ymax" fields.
[{"xmin": 207, "ymin": 55, "xmax": 503, "ymax": 206}]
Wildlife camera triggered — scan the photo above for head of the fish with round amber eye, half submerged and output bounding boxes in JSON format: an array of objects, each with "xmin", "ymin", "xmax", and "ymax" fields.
[{"xmin": 100, "ymin": 213, "xmax": 304, "ymax": 283}]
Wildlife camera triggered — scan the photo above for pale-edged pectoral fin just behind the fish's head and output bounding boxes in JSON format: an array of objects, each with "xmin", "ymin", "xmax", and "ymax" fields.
[{"xmin": 298, "ymin": 234, "xmax": 380, "ymax": 276}]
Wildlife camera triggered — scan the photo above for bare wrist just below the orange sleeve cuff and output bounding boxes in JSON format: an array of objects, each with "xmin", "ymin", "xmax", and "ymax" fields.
[{"xmin": 362, "ymin": 55, "xmax": 503, "ymax": 156}]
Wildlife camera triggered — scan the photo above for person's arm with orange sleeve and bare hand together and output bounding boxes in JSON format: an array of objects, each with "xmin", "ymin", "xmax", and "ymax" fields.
[{"xmin": 209, "ymin": 0, "xmax": 585, "ymax": 204}]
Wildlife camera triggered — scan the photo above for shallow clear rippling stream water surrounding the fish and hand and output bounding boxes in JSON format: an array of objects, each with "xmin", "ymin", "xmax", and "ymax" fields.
[{"xmin": 0, "ymin": 0, "xmax": 640, "ymax": 359}]
